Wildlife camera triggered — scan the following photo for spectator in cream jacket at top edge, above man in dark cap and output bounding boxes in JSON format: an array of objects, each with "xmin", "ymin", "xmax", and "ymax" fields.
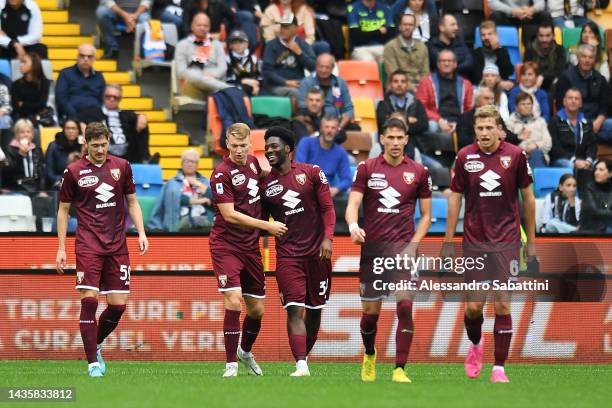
[{"xmin": 259, "ymin": 0, "xmax": 330, "ymax": 55}]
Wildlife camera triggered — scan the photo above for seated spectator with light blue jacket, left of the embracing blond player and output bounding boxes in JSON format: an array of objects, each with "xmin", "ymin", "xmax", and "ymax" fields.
[{"xmin": 147, "ymin": 149, "xmax": 213, "ymax": 232}]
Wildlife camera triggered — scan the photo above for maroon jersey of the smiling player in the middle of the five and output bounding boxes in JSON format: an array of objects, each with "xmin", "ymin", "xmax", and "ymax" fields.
[{"xmin": 261, "ymin": 163, "xmax": 336, "ymax": 258}]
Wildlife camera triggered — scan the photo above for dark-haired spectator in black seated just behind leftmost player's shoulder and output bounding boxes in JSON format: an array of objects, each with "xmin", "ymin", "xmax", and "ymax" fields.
[{"xmin": 45, "ymin": 118, "xmax": 81, "ymax": 189}]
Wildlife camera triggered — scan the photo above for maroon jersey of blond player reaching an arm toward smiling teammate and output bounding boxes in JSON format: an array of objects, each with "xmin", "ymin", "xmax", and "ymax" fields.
[{"xmin": 210, "ymin": 155, "xmax": 261, "ymax": 252}]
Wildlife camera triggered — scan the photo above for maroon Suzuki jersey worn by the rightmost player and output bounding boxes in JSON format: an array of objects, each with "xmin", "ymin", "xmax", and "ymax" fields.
[{"xmin": 450, "ymin": 140, "xmax": 533, "ymax": 250}]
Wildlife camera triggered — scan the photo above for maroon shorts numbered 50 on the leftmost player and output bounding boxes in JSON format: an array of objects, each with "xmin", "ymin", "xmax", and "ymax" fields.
[{"xmin": 76, "ymin": 253, "xmax": 131, "ymax": 295}]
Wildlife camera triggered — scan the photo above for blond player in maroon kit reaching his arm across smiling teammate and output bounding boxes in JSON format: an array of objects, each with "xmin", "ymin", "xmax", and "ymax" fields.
[{"xmin": 210, "ymin": 123, "xmax": 287, "ymax": 377}]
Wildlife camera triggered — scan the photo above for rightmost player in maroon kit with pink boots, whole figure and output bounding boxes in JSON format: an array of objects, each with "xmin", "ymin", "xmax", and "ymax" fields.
[{"xmin": 442, "ymin": 105, "xmax": 535, "ymax": 382}]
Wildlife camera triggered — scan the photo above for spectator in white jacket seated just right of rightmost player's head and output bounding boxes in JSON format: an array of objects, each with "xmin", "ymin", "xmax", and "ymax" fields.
[{"xmin": 506, "ymin": 92, "xmax": 552, "ymax": 167}]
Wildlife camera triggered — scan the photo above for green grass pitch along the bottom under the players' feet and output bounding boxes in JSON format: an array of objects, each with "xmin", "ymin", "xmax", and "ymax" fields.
[{"xmin": 0, "ymin": 361, "xmax": 612, "ymax": 408}]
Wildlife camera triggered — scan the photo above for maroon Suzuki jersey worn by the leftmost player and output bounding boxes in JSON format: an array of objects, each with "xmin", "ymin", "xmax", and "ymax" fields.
[{"xmin": 59, "ymin": 155, "xmax": 136, "ymax": 255}]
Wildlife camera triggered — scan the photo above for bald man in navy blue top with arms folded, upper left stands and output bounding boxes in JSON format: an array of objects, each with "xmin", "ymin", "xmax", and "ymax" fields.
[{"xmin": 55, "ymin": 44, "xmax": 106, "ymax": 118}]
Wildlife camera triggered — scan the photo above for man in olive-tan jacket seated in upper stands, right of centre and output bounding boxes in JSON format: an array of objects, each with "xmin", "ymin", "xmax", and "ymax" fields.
[{"xmin": 383, "ymin": 14, "xmax": 429, "ymax": 92}]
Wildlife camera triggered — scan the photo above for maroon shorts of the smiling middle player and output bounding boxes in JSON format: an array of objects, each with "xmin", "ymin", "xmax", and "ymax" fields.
[{"xmin": 276, "ymin": 258, "xmax": 331, "ymax": 309}]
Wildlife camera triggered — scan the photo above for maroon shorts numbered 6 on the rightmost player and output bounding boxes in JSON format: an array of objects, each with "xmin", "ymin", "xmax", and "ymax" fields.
[{"xmin": 463, "ymin": 248, "xmax": 521, "ymax": 282}]
